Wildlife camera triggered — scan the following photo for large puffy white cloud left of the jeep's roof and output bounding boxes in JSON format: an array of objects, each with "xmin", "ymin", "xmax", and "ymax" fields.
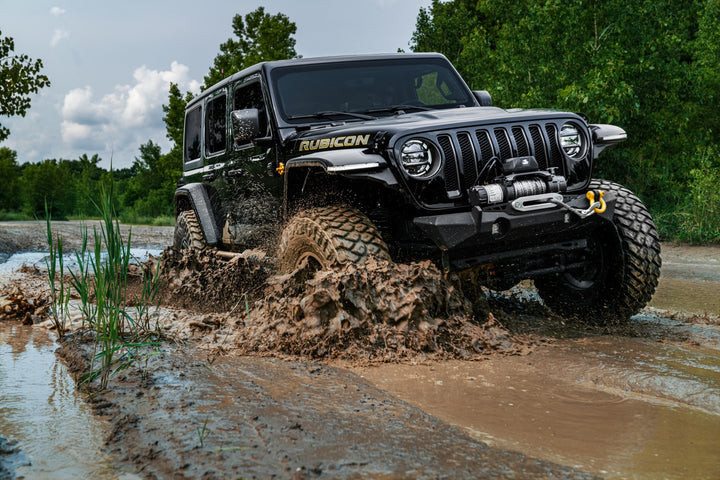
[{"xmin": 60, "ymin": 62, "xmax": 200, "ymax": 163}]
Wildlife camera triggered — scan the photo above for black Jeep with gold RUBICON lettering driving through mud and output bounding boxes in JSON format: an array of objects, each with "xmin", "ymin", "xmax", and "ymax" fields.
[{"xmin": 174, "ymin": 54, "xmax": 660, "ymax": 321}]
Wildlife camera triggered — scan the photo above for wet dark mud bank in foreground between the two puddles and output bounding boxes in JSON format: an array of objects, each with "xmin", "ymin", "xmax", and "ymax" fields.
[{"xmin": 54, "ymin": 338, "xmax": 594, "ymax": 479}]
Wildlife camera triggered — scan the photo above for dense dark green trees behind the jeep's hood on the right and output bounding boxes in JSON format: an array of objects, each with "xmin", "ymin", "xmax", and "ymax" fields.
[{"xmin": 413, "ymin": 0, "xmax": 720, "ymax": 242}]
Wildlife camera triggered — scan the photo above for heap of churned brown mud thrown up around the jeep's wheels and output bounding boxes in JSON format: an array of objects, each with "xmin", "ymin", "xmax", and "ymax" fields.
[{"xmin": 158, "ymin": 251, "xmax": 530, "ymax": 361}]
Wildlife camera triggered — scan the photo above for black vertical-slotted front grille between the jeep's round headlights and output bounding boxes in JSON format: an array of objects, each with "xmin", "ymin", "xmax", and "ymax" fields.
[{"xmin": 437, "ymin": 122, "xmax": 564, "ymax": 200}]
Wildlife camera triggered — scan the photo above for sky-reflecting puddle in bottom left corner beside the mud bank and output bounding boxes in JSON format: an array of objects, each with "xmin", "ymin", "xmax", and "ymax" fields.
[{"xmin": 0, "ymin": 322, "xmax": 135, "ymax": 479}]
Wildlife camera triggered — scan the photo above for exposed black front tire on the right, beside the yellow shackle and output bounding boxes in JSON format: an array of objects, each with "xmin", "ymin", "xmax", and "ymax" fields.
[{"xmin": 535, "ymin": 180, "xmax": 661, "ymax": 324}]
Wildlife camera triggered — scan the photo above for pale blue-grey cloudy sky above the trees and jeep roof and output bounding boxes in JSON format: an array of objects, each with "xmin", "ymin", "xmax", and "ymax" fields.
[{"xmin": 0, "ymin": 0, "xmax": 431, "ymax": 168}]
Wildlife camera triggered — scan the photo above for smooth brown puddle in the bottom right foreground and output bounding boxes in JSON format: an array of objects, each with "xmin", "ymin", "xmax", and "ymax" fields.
[{"xmin": 353, "ymin": 337, "xmax": 720, "ymax": 479}]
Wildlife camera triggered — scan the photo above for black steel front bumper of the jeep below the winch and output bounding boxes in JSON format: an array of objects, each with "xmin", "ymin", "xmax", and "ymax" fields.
[{"xmin": 413, "ymin": 192, "xmax": 615, "ymax": 270}]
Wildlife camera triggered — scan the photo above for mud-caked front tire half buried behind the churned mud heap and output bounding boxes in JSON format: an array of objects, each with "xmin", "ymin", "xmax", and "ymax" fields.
[{"xmin": 278, "ymin": 205, "xmax": 390, "ymax": 272}]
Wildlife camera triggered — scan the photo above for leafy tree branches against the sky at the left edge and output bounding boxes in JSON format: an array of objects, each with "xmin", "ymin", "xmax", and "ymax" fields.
[{"xmin": 0, "ymin": 31, "xmax": 50, "ymax": 142}]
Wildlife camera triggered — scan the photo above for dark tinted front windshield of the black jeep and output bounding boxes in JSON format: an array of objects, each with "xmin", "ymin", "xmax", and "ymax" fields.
[{"xmin": 271, "ymin": 57, "xmax": 474, "ymax": 123}]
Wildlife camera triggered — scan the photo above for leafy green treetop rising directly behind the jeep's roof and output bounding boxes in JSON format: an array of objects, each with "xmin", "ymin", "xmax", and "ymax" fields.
[{"xmin": 203, "ymin": 7, "xmax": 297, "ymax": 90}]
